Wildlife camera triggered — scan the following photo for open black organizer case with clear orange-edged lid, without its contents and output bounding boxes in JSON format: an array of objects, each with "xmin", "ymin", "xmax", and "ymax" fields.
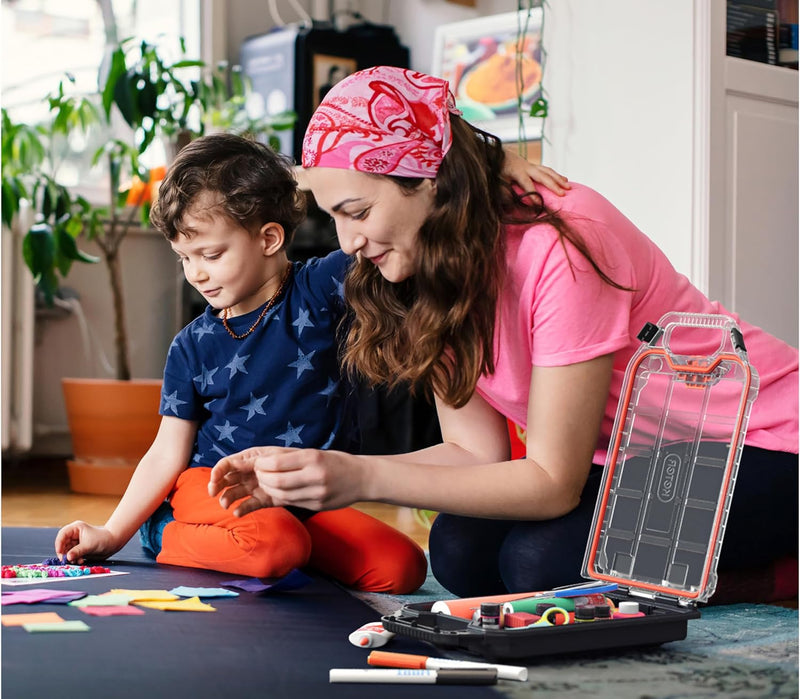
[{"xmin": 382, "ymin": 313, "xmax": 758, "ymax": 660}]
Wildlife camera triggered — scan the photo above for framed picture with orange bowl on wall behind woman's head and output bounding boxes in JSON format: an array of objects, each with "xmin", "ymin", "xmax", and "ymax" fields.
[{"xmin": 432, "ymin": 7, "xmax": 542, "ymax": 142}]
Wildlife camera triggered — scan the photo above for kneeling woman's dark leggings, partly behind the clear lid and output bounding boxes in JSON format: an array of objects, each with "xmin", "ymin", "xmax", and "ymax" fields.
[{"xmin": 429, "ymin": 446, "xmax": 798, "ymax": 597}]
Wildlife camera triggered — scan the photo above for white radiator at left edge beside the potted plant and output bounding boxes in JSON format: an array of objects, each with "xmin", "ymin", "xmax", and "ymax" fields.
[{"xmin": 0, "ymin": 213, "xmax": 35, "ymax": 452}]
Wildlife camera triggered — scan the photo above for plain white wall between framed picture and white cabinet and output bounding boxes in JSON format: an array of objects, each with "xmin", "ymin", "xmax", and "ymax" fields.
[{"xmin": 542, "ymin": 0, "xmax": 694, "ymax": 275}]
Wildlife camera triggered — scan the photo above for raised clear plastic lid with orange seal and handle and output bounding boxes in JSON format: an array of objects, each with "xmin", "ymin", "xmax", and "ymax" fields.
[{"xmin": 583, "ymin": 313, "xmax": 758, "ymax": 604}]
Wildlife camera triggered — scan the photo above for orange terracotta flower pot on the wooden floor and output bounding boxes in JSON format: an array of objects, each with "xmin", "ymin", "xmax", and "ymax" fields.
[{"xmin": 61, "ymin": 379, "xmax": 161, "ymax": 495}]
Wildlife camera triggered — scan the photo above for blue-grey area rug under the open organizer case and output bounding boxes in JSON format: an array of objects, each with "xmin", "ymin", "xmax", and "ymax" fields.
[{"xmin": 359, "ymin": 564, "xmax": 798, "ymax": 699}]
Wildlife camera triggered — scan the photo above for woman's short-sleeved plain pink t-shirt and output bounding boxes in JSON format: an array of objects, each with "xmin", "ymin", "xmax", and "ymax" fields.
[{"xmin": 477, "ymin": 183, "xmax": 798, "ymax": 464}]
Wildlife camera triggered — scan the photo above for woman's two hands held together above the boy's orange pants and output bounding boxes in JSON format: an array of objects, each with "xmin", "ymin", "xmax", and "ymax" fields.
[{"xmin": 208, "ymin": 447, "xmax": 364, "ymax": 517}]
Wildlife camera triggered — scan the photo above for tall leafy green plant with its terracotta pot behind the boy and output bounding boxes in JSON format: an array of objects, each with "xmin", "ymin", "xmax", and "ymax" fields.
[{"xmin": 2, "ymin": 39, "xmax": 294, "ymax": 493}]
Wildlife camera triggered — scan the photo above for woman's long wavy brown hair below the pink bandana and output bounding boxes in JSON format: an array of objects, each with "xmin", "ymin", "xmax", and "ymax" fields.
[{"xmin": 343, "ymin": 116, "xmax": 624, "ymax": 408}]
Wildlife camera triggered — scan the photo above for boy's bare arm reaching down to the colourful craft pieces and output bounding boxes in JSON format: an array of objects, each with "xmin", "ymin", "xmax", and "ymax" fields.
[{"xmin": 55, "ymin": 416, "xmax": 197, "ymax": 563}]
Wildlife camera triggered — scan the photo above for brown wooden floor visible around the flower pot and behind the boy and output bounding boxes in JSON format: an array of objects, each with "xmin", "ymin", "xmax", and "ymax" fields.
[{"xmin": 1, "ymin": 459, "xmax": 428, "ymax": 550}]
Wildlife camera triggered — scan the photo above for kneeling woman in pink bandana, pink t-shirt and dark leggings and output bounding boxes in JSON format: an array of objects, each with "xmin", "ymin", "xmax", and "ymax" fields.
[{"xmin": 209, "ymin": 67, "xmax": 798, "ymax": 596}]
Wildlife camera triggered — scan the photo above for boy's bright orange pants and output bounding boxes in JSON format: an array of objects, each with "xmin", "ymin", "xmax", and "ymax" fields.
[{"xmin": 156, "ymin": 467, "xmax": 427, "ymax": 594}]
